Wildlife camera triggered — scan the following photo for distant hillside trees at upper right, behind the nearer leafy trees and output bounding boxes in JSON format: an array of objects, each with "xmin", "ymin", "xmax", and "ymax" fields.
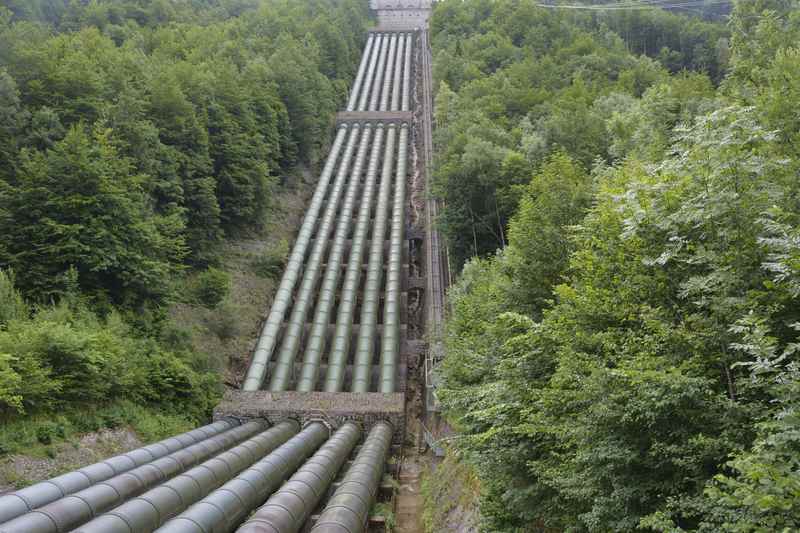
[{"xmin": 431, "ymin": 0, "xmax": 727, "ymax": 265}]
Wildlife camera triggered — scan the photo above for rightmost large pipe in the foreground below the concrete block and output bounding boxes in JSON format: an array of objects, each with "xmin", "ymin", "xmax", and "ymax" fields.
[{"xmin": 311, "ymin": 422, "xmax": 394, "ymax": 533}]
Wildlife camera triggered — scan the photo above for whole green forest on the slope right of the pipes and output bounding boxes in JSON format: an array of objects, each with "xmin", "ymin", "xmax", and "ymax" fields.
[{"xmin": 431, "ymin": 0, "xmax": 800, "ymax": 532}]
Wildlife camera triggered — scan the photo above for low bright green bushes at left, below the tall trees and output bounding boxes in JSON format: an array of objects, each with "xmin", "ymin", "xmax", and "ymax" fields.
[{"xmin": 0, "ymin": 274, "xmax": 219, "ymax": 419}]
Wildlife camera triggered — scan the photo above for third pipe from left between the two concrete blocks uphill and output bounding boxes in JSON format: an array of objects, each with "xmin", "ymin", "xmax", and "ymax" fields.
[{"xmin": 297, "ymin": 124, "xmax": 372, "ymax": 392}]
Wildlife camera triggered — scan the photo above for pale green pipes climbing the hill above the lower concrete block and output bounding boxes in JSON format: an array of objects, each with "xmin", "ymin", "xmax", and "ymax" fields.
[{"xmin": 242, "ymin": 32, "xmax": 414, "ymax": 393}]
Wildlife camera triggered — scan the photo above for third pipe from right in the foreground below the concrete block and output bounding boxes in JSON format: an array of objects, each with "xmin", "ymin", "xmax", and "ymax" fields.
[{"xmin": 157, "ymin": 422, "xmax": 330, "ymax": 533}]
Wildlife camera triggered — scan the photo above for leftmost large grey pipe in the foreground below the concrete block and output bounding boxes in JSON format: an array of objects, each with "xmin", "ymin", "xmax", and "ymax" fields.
[{"xmin": 0, "ymin": 418, "xmax": 239, "ymax": 524}]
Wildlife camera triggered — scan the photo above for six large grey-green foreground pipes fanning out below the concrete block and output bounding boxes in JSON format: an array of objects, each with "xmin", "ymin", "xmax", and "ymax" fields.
[{"xmin": 0, "ymin": 418, "xmax": 393, "ymax": 533}]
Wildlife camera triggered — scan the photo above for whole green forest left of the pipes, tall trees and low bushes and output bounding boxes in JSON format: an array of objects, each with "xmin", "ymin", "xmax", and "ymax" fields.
[{"xmin": 0, "ymin": 0, "xmax": 368, "ymax": 448}]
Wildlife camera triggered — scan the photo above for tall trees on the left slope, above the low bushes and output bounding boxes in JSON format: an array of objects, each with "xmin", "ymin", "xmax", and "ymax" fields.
[{"xmin": 0, "ymin": 0, "xmax": 367, "ymax": 298}]
